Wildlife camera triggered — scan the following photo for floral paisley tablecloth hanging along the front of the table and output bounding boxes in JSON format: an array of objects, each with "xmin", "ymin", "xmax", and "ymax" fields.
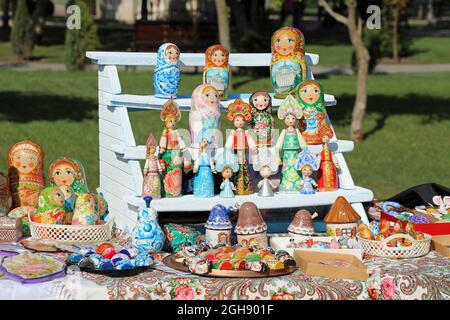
[{"xmin": 55, "ymin": 251, "xmax": 450, "ymax": 300}]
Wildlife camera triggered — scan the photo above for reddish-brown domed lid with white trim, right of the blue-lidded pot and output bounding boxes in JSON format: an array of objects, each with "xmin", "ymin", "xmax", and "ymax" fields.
[{"xmin": 234, "ymin": 202, "xmax": 267, "ymax": 234}]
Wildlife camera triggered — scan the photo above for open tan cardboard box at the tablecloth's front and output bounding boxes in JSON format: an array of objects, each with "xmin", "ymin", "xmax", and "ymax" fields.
[{"xmin": 294, "ymin": 250, "xmax": 369, "ymax": 281}]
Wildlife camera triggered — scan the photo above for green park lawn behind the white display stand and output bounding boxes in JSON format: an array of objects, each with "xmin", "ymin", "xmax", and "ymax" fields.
[{"xmin": 0, "ymin": 71, "xmax": 450, "ymax": 198}]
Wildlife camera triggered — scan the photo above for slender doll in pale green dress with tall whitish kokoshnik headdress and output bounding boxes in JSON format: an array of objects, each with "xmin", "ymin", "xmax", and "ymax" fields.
[{"xmin": 276, "ymin": 95, "xmax": 307, "ymax": 192}]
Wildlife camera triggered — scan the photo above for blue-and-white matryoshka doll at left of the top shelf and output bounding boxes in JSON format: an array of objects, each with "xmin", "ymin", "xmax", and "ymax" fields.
[{"xmin": 153, "ymin": 43, "xmax": 180, "ymax": 99}]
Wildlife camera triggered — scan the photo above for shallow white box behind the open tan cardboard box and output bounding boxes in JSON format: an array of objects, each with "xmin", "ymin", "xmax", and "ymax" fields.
[{"xmin": 270, "ymin": 236, "xmax": 364, "ymax": 260}]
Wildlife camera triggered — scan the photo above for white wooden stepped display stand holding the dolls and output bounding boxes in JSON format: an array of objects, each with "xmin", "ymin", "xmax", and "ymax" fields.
[{"xmin": 86, "ymin": 52, "xmax": 373, "ymax": 228}]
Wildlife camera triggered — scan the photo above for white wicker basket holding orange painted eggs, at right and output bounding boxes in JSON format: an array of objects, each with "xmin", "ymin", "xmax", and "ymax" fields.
[{"xmin": 357, "ymin": 234, "xmax": 431, "ymax": 258}]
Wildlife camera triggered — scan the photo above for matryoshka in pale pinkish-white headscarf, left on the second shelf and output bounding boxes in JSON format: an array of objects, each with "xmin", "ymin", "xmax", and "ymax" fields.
[{"xmin": 189, "ymin": 84, "xmax": 221, "ymax": 153}]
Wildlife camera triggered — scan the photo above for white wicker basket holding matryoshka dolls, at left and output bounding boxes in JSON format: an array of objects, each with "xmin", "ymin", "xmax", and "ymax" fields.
[{"xmin": 29, "ymin": 217, "xmax": 114, "ymax": 244}]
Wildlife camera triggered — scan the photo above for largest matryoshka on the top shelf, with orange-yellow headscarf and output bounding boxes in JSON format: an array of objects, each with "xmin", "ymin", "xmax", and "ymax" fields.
[{"xmin": 270, "ymin": 27, "xmax": 307, "ymax": 99}]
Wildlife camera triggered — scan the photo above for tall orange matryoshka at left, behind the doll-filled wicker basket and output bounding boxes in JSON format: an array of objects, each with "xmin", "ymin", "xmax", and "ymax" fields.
[{"xmin": 8, "ymin": 140, "xmax": 45, "ymax": 208}]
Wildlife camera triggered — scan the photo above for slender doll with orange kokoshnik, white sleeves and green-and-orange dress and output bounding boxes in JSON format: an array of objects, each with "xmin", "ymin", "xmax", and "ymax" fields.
[{"xmin": 159, "ymin": 99, "xmax": 185, "ymax": 197}]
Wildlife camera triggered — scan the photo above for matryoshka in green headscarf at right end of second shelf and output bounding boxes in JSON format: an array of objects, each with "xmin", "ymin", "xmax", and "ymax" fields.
[{"xmin": 297, "ymin": 80, "xmax": 334, "ymax": 145}]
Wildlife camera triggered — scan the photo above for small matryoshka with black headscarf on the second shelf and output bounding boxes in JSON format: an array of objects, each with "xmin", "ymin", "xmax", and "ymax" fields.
[{"xmin": 248, "ymin": 91, "xmax": 274, "ymax": 148}]
